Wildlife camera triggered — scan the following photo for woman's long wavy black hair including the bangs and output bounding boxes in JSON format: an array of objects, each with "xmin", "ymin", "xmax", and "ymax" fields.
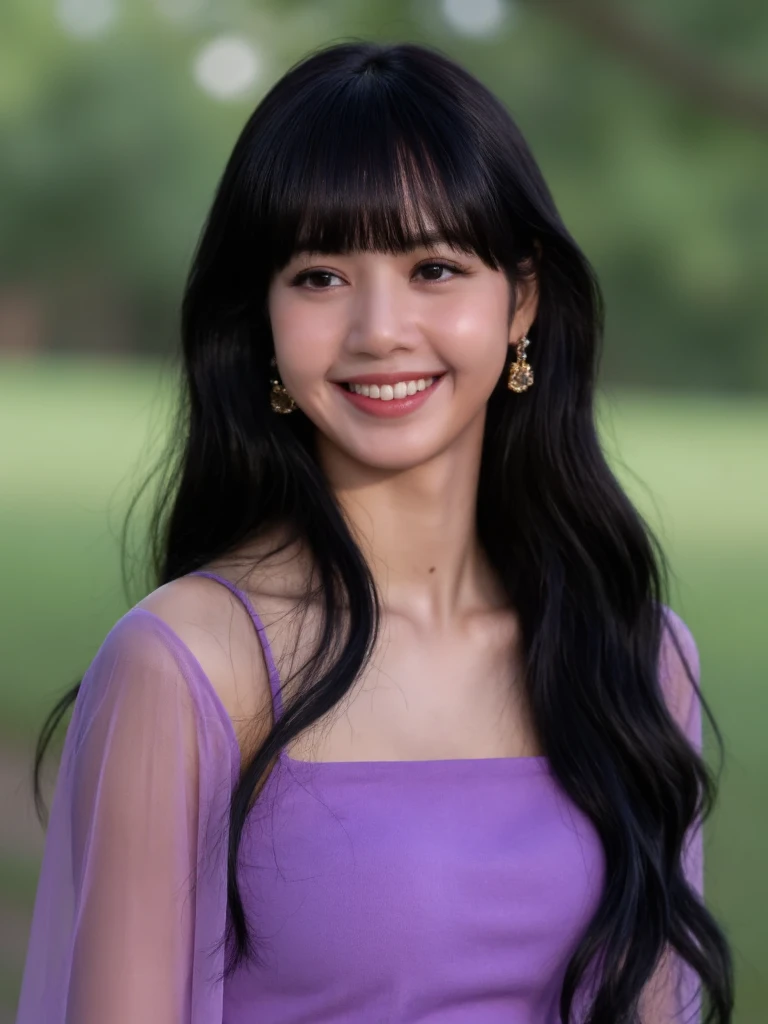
[{"xmin": 35, "ymin": 42, "xmax": 733, "ymax": 1024}]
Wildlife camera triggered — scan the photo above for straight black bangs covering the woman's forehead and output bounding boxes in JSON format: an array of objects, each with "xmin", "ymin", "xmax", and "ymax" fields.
[{"xmin": 249, "ymin": 55, "xmax": 518, "ymax": 271}]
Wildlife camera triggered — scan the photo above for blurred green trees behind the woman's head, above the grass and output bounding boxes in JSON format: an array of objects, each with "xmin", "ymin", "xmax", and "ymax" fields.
[{"xmin": 0, "ymin": 0, "xmax": 768, "ymax": 390}]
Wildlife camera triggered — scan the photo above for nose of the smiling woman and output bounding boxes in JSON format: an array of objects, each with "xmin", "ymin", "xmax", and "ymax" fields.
[{"xmin": 345, "ymin": 269, "xmax": 416, "ymax": 359}]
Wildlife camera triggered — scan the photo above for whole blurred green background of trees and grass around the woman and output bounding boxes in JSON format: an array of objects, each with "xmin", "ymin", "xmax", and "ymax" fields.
[{"xmin": 0, "ymin": 0, "xmax": 768, "ymax": 1024}]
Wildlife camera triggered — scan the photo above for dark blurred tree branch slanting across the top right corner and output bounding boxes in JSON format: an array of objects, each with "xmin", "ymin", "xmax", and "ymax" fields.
[{"xmin": 526, "ymin": 0, "xmax": 768, "ymax": 132}]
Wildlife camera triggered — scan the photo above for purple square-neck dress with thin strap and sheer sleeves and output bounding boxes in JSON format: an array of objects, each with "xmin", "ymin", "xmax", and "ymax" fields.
[{"xmin": 16, "ymin": 573, "xmax": 703, "ymax": 1024}]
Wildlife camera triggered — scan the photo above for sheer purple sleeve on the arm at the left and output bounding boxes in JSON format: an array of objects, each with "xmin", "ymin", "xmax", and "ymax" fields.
[{"xmin": 16, "ymin": 608, "xmax": 240, "ymax": 1024}]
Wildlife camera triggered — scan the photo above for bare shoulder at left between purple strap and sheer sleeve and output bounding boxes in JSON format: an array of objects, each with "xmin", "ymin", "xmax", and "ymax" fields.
[{"xmin": 137, "ymin": 570, "xmax": 272, "ymax": 753}]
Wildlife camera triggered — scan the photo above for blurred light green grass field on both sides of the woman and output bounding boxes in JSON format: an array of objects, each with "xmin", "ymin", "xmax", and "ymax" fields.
[{"xmin": 0, "ymin": 360, "xmax": 768, "ymax": 1024}]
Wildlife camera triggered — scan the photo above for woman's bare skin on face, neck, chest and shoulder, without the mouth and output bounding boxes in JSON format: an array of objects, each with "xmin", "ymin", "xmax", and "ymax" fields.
[{"xmin": 143, "ymin": 214, "xmax": 541, "ymax": 761}]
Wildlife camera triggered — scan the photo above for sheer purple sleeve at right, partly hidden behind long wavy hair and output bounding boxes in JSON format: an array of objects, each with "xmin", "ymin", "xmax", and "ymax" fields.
[{"xmin": 642, "ymin": 608, "xmax": 705, "ymax": 1024}]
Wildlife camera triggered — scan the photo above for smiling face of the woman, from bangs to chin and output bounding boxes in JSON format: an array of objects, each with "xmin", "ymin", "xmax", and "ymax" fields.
[{"xmin": 268, "ymin": 226, "xmax": 537, "ymax": 470}]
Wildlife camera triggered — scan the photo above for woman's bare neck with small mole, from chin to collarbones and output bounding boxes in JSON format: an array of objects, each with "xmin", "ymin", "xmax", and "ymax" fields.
[{"xmin": 318, "ymin": 415, "xmax": 503, "ymax": 627}]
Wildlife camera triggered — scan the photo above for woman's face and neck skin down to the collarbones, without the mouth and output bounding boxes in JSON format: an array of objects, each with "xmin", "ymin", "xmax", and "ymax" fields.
[{"xmin": 268, "ymin": 230, "xmax": 538, "ymax": 630}]
